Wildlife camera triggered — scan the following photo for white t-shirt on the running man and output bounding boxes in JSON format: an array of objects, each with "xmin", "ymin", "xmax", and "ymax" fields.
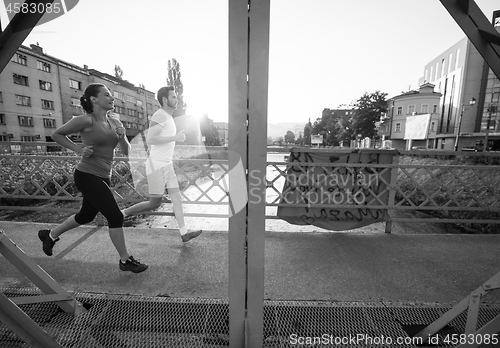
[{"xmin": 149, "ymin": 109, "xmax": 177, "ymax": 162}]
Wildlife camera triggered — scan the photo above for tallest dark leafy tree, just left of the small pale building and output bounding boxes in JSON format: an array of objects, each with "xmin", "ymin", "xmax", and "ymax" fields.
[{"xmin": 353, "ymin": 91, "xmax": 387, "ymax": 138}]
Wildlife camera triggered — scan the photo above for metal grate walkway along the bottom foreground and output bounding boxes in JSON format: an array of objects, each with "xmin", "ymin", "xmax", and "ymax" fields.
[{"xmin": 0, "ymin": 289, "xmax": 500, "ymax": 348}]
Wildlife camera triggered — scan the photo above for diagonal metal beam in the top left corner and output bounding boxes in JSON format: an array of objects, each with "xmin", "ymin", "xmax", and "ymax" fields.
[{"xmin": 0, "ymin": 0, "xmax": 54, "ymax": 72}]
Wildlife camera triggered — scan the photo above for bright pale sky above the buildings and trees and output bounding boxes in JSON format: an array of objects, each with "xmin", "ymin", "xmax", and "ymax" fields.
[{"xmin": 0, "ymin": 0, "xmax": 500, "ymax": 123}]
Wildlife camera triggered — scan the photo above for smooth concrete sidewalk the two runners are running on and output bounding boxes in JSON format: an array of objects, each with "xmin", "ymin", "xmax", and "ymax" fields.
[{"xmin": 0, "ymin": 221, "xmax": 500, "ymax": 304}]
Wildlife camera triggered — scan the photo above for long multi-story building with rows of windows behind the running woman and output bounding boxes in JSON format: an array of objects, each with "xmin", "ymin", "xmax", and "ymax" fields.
[{"xmin": 0, "ymin": 45, "xmax": 160, "ymax": 147}]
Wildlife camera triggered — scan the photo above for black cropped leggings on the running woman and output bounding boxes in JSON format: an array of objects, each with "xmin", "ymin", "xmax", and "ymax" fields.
[{"xmin": 74, "ymin": 170, "xmax": 123, "ymax": 228}]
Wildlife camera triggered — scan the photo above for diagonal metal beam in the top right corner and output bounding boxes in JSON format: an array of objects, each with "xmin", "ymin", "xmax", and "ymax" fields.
[{"xmin": 440, "ymin": 0, "xmax": 500, "ymax": 79}]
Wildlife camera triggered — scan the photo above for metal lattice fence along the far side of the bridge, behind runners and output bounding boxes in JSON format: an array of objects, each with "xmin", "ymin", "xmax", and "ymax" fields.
[{"xmin": 0, "ymin": 145, "xmax": 500, "ymax": 229}]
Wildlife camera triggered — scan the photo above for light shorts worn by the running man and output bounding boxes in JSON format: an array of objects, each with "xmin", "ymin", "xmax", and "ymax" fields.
[{"xmin": 146, "ymin": 160, "xmax": 179, "ymax": 195}]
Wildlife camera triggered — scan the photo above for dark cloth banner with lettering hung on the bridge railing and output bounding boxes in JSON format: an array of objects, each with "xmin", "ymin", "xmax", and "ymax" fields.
[{"xmin": 277, "ymin": 149, "xmax": 398, "ymax": 231}]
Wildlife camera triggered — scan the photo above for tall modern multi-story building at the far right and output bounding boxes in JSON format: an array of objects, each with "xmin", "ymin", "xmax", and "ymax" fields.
[{"xmin": 419, "ymin": 11, "xmax": 500, "ymax": 150}]
